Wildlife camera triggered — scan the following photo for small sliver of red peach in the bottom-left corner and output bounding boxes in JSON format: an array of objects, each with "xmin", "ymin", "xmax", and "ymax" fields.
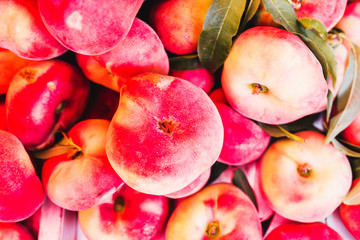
[{"xmin": 0, "ymin": 223, "xmax": 35, "ymax": 240}]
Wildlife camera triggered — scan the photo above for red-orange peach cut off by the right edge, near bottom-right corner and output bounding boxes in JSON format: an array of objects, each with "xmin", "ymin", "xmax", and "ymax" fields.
[{"xmin": 339, "ymin": 178, "xmax": 360, "ymax": 239}]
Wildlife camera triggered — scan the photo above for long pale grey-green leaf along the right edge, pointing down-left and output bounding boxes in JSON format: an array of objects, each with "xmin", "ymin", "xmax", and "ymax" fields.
[{"xmin": 326, "ymin": 40, "xmax": 360, "ymax": 143}]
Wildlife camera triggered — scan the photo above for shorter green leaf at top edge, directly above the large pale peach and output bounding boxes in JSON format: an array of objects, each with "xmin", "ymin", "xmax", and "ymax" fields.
[{"xmin": 263, "ymin": 0, "xmax": 302, "ymax": 33}]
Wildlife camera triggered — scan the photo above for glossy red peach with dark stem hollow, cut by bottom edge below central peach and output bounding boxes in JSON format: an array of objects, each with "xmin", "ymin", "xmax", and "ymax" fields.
[{"xmin": 78, "ymin": 184, "xmax": 170, "ymax": 240}]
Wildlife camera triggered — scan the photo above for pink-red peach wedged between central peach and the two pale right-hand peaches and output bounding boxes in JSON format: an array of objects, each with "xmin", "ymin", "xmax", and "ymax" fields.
[{"xmin": 215, "ymin": 103, "xmax": 271, "ymax": 166}]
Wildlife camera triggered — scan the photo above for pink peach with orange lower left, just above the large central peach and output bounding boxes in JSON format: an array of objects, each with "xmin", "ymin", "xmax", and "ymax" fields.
[{"xmin": 77, "ymin": 18, "xmax": 169, "ymax": 91}]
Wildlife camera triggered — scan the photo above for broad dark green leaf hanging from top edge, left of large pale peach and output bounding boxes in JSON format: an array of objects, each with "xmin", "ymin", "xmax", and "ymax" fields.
[{"xmin": 198, "ymin": 0, "xmax": 246, "ymax": 72}]
